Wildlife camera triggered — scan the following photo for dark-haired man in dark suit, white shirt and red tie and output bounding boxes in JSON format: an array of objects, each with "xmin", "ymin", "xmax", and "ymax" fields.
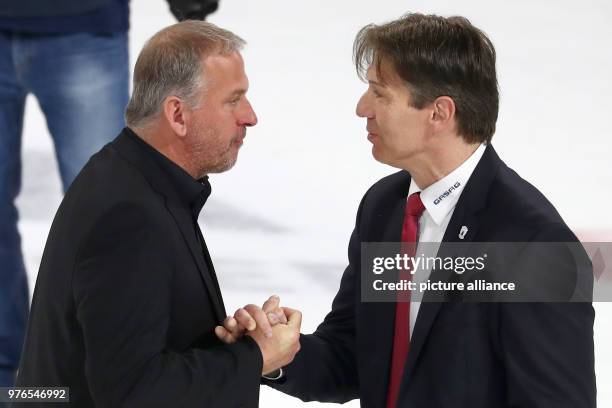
[{"xmin": 218, "ymin": 14, "xmax": 595, "ymax": 408}]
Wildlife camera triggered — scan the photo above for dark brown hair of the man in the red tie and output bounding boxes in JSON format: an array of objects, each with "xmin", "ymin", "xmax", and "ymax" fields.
[{"xmin": 353, "ymin": 13, "xmax": 499, "ymax": 143}]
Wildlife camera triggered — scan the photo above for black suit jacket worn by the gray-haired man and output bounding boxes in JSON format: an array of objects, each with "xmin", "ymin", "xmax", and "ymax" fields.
[{"xmin": 17, "ymin": 131, "xmax": 262, "ymax": 408}]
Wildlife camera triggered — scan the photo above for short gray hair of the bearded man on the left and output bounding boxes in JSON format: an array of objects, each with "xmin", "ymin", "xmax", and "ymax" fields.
[{"xmin": 125, "ymin": 20, "xmax": 245, "ymax": 127}]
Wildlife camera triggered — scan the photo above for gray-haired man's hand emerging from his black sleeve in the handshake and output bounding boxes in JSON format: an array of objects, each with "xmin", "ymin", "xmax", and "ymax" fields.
[{"xmin": 247, "ymin": 307, "xmax": 302, "ymax": 375}]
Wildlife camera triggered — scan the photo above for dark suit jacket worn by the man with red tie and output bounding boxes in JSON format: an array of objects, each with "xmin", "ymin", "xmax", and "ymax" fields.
[{"xmin": 268, "ymin": 146, "xmax": 596, "ymax": 408}]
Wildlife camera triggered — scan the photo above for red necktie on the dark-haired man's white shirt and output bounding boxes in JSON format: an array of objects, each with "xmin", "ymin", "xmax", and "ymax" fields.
[{"xmin": 387, "ymin": 193, "xmax": 425, "ymax": 408}]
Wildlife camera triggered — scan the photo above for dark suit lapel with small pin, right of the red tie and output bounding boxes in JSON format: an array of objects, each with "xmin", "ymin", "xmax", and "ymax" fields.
[{"xmin": 400, "ymin": 145, "xmax": 503, "ymax": 386}]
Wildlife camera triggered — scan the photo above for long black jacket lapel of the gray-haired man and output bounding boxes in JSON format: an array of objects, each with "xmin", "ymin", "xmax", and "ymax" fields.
[{"xmin": 112, "ymin": 130, "xmax": 226, "ymax": 322}]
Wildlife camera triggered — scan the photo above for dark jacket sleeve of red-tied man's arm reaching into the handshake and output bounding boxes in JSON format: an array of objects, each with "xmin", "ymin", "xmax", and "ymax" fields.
[{"xmin": 263, "ymin": 193, "xmax": 367, "ymax": 403}]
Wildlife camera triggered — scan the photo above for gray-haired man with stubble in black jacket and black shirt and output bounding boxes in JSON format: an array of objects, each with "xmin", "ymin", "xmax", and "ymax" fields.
[{"xmin": 17, "ymin": 21, "xmax": 301, "ymax": 408}]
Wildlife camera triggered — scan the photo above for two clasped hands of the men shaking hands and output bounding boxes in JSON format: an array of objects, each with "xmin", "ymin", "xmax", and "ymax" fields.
[{"xmin": 215, "ymin": 295, "xmax": 302, "ymax": 374}]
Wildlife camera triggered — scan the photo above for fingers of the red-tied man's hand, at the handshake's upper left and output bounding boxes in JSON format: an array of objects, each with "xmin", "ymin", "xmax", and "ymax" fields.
[{"xmin": 215, "ymin": 295, "xmax": 287, "ymax": 344}]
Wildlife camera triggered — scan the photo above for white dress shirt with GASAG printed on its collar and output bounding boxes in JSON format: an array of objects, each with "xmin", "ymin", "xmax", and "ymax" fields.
[{"xmin": 408, "ymin": 144, "xmax": 485, "ymax": 337}]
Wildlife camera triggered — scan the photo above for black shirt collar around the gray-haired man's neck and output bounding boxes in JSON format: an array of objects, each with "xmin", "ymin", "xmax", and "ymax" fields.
[{"xmin": 126, "ymin": 128, "xmax": 211, "ymax": 218}]
